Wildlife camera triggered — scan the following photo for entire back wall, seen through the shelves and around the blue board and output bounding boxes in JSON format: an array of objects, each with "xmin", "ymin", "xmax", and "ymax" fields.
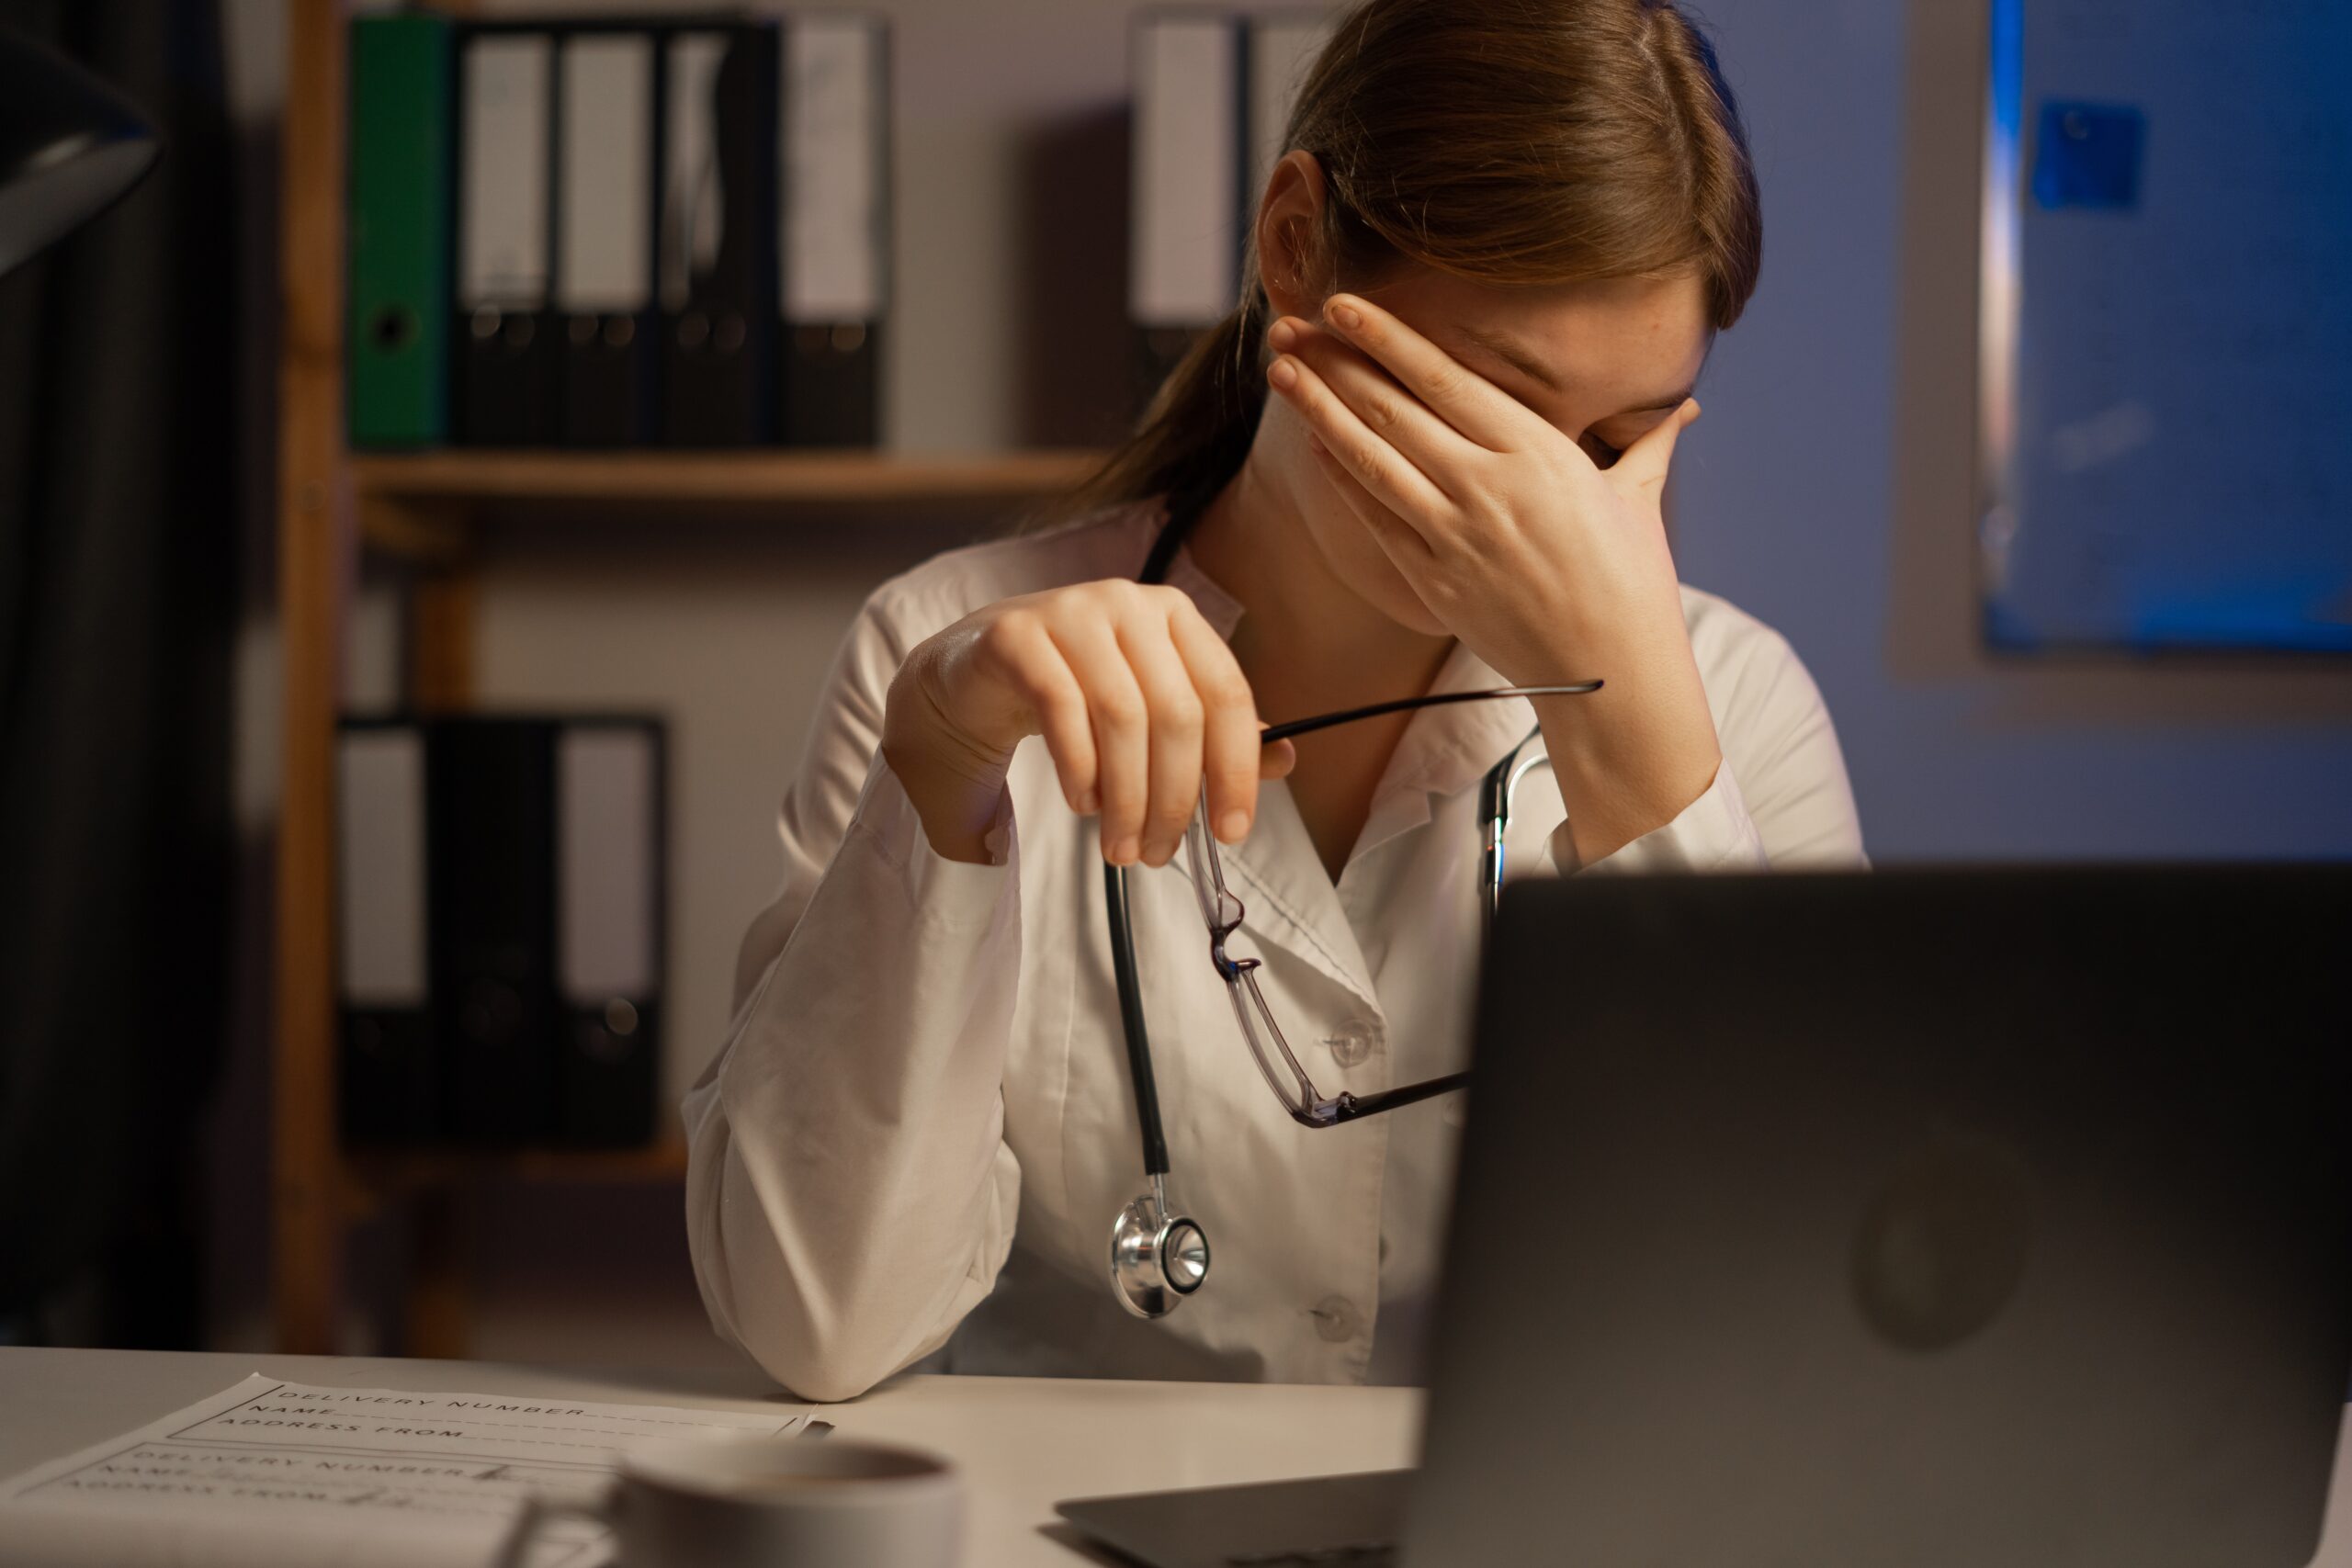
[{"xmin": 223, "ymin": 0, "xmax": 2352, "ymax": 1361}]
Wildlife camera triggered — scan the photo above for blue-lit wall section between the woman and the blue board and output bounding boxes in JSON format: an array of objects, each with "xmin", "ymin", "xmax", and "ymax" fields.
[{"xmin": 1675, "ymin": 0, "xmax": 2352, "ymax": 863}]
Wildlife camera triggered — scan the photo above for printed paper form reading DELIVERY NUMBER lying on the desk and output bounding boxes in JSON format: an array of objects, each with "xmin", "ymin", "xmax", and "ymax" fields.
[{"xmin": 0, "ymin": 1375, "xmax": 809, "ymax": 1568}]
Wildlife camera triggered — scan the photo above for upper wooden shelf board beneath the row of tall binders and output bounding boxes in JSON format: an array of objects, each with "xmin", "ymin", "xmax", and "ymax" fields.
[{"xmin": 350, "ymin": 449, "xmax": 1105, "ymax": 505}]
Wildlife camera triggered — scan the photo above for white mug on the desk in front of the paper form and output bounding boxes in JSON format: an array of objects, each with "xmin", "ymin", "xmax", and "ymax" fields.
[{"xmin": 499, "ymin": 1438, "xmax": 962, "ymax": 1568}]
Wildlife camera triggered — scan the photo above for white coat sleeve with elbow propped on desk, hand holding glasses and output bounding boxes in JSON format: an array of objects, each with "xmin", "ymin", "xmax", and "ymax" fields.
[{"xmin": 682, "ymin": 582, "xmax": 1021, "ymax": 1399}]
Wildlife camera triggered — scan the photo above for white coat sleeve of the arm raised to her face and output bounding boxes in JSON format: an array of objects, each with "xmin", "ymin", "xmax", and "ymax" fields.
[{"xmin": 1545, "ymin": 618, "xmax": 1868, "ymax": 874}]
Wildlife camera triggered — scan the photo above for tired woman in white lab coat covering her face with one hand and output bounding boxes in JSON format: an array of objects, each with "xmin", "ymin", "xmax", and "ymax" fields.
[{"xmin": 684, "ymin": 0, "xmax": 1860, "ymax": 1399}]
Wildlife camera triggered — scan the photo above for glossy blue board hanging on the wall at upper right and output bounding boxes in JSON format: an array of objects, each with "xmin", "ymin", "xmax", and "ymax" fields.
[{"xmin": 1981, "ymin": 0, "xmax": 2352, "ymax": 651}]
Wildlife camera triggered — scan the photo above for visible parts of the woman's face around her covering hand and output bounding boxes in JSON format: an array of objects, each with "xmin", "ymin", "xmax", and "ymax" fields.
[{"xmin": 1261, "ymin": 268, "xmax": 1713, "ymax": 637}]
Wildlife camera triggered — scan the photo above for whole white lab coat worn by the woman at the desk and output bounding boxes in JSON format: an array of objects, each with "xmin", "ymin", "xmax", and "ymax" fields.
[{"xmin": 684, "ymin": 503, "xmax": 1860, "ymax": 1399}]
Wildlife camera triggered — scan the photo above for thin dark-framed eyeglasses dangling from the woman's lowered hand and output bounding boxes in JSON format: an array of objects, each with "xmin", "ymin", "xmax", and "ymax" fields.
[{"xmin": 1183, "ymin": 680, "xmax": 1601, "ymax": 1128}]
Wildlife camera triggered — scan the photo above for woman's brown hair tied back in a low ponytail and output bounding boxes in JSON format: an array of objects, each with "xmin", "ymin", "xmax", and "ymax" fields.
[{"xmin": 1040, "ymin": 0, "xmax": 1764, "ymax": 522}]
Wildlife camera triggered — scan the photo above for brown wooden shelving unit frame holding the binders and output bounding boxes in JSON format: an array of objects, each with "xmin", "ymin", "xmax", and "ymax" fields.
[{"xmin": 268, "ymin": 0, "xmax": 1114, "ymax": 1357}]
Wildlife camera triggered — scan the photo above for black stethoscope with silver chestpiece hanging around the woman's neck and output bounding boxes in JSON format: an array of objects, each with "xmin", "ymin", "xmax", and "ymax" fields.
[{"xmin": 1103, "ymin": 474, "xmax": 1550, "ymax": 1319}]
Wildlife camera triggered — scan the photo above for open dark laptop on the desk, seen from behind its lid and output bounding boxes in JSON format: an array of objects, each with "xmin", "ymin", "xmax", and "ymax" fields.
[{"xmin": 1061, "ymin": 865, "xmax": 2352, "ymax": 1568}]
